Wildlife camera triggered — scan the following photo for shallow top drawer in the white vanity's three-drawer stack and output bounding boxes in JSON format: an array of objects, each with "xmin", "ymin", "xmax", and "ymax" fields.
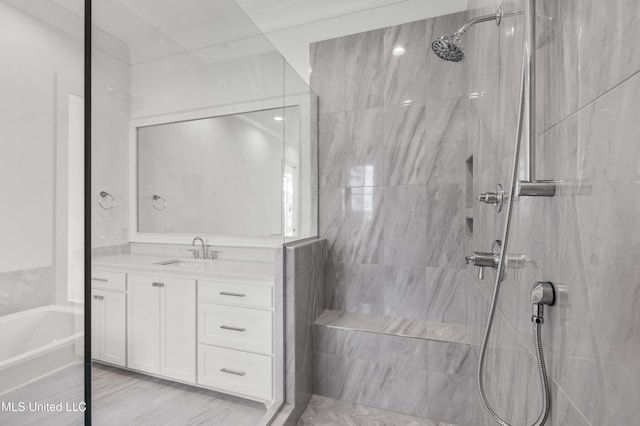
[{"xmin": 198, "ymin": 281, "xmax": 273, "ymax": 308}]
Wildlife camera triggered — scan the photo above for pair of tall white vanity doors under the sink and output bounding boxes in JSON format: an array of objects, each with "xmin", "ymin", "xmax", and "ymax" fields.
[{"xmin": 127, "ymin": 274, "xmax": 196, "ymax": 383}]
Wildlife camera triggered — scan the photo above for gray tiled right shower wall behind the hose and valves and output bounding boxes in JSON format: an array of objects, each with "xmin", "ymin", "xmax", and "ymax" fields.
[{"xmin": 464, "ymin": 0, "xmax": 640, "ymax": 426}]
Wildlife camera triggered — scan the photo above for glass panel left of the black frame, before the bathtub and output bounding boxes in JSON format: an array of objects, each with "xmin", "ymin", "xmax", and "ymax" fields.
[{"xmin": 0, "ymin": 1, "xmax": 84, "ymax": 424}]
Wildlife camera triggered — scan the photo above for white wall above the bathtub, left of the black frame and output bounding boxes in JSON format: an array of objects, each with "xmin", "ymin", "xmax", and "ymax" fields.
[{"xmin": 0, "ymin": 2, "xmax": 83, "ymax": 272}]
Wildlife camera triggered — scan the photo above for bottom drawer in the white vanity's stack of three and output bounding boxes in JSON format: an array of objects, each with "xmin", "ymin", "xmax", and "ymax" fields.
[{"xmin": 198, "ymin": 345, "xmax": 273, "ymax": 400}]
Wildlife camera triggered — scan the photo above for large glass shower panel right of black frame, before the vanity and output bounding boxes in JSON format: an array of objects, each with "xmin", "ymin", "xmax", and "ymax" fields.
[{"xmin": 91, "ymin": 0, "xmax": 291, "ymax": 426}]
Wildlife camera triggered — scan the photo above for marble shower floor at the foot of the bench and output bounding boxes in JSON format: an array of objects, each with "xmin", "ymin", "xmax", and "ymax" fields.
[{"xmin": 298, "ymin": 395, "xmax": 455, "ymax": 426}]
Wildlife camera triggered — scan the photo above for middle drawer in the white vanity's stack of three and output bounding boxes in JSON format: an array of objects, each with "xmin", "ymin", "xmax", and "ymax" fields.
[{"xmin": 198, "ymin": 302, "xmax": 273, "ymax": 355}]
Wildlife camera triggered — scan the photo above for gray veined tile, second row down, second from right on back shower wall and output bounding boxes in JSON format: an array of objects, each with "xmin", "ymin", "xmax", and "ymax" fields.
[{"xmin": 384, "ymin": 103, "xmax": 426, "ymax": 185}]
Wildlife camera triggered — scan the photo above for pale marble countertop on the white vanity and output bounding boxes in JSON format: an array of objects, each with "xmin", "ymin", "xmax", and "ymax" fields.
[{"xmin": 92, "ymin": 254, "xmax": 275, "ymax": 284}]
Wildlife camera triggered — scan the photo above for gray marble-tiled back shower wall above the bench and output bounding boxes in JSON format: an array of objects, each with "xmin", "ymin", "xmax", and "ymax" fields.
[{"xmin": 311, "ymin": 14, "xmax": 468, "ymax": 324}]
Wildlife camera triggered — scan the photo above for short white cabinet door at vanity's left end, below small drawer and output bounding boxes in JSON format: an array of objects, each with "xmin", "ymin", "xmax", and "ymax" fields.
[{"xmin": 100, "ymin": 291, "xmax": 127, "ymax": 367}]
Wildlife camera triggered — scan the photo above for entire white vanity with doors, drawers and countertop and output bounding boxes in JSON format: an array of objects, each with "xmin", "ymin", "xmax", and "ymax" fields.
[{"xmin": 92, "ymin": 255, "xmax": 275, "ymax": 406}]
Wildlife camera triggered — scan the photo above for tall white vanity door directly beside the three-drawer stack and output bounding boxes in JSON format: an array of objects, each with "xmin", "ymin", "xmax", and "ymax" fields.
[{"xmin": 160, "ymin": 278, "xmax": 196, "ymax": 383}]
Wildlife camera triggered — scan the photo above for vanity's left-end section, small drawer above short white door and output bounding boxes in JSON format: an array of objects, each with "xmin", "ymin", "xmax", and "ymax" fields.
[{"xmin": 91, "ymin": 270, "xmax": 127, "ymax": 367}]
